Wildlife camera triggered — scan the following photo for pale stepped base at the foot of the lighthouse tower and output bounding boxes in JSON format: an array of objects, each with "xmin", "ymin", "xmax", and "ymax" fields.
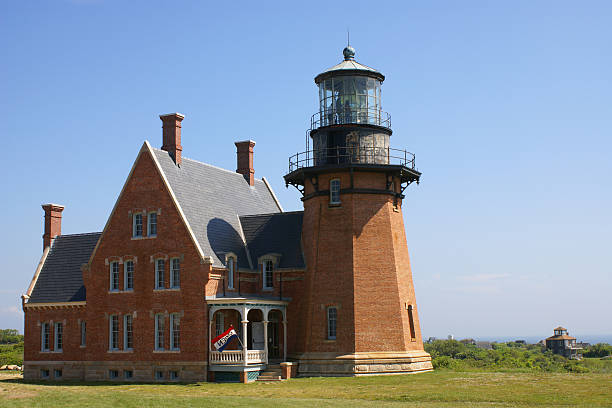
[{"xmin": 293, "ymin": 350, "xmax": 433, "ymax": 377}]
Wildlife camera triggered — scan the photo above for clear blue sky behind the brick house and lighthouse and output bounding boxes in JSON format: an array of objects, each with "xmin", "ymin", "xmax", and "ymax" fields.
[{"xmin": 0, "ymin": 0, "xmax": 612, "ymax": 338}]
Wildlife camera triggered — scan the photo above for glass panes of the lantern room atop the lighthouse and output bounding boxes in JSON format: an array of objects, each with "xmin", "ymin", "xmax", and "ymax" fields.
[{"xmin": 319, "ymin": 75, "xmax": 382, "ymax": 126}]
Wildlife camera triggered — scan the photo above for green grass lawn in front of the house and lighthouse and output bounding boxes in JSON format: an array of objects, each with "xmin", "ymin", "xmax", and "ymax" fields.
[{"xmin": 0, "ymin": 370, "xmax": 612, "ymax": 407}]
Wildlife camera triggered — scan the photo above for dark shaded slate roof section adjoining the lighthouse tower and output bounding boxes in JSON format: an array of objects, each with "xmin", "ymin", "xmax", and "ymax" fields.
[{"xmin": 240, "ymin": 211, "xmax": 305, "ymax": 268}]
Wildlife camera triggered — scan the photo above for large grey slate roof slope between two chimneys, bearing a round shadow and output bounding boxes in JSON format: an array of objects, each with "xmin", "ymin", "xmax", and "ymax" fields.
[{"xmin": 152, "ymin": 148, "xmax": 284, "ymax": 268}]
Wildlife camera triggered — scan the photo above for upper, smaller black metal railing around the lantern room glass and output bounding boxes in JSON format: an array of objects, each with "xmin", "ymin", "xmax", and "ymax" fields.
[{"xmin": 310, "ymin": 106, "xmax": 391, "ymax": 129}]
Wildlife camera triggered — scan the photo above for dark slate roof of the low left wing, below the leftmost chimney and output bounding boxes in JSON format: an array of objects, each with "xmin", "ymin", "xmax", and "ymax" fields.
[{"xmin": 28, "ymin": 232, "xmax": 102, "ymax": 303}]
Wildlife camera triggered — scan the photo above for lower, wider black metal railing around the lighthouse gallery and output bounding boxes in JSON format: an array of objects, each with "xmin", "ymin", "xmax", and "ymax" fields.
[{"xmin": 289, "ymin": 146, "xmax": 415, "ymax": 172}]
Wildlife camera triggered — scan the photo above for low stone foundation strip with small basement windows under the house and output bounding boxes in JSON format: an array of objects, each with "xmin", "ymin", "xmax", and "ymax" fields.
[{"xmin": 23, "ymin": 361, "xmax": 208, "ymax": 382}]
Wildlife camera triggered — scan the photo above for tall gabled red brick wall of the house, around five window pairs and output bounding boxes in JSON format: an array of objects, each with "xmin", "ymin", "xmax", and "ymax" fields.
[{"xmin": 83, "ymin": 151, "xmax": 210, "ymax": 361}]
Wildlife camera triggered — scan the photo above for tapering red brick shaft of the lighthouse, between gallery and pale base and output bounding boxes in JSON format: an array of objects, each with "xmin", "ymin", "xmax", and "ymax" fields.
[{"xmin": 296, "ymin": 172, "xmax": 423, "ymax": 353}]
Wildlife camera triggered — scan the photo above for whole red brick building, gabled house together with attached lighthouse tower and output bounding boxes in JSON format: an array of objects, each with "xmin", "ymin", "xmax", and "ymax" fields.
[{"xmin": 22, "ymin": 46, "xmax": 432, "ymax": 382}]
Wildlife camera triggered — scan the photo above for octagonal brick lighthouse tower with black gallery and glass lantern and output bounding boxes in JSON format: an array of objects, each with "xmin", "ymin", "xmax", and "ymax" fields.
[{"xmin": 285, "ymin": 46, "xmax": 432, "ymax": 375}]
